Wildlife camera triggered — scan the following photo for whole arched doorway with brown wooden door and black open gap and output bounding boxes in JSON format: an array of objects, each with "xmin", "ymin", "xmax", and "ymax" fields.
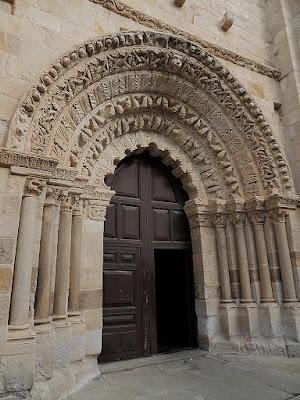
[{"xmin": 100, "ymin": 153, "xmax": 197, "ymax": 361}]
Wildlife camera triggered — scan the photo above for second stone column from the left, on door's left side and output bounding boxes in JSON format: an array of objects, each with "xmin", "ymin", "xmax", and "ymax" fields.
[{"xmin": 35, "ymin": 186, "xmax": 60, "ymax": 324}]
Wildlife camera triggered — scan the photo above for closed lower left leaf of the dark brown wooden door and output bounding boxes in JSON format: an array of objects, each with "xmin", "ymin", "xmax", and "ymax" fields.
[{"xmin": 100, "ymin": 246, "xmax": 141, "ymax": 361}]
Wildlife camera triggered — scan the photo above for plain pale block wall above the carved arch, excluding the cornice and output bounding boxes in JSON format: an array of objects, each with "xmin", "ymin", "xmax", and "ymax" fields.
[{"xmin": 0, "ymin": 0, "xmax": 285, "ymax": 155}]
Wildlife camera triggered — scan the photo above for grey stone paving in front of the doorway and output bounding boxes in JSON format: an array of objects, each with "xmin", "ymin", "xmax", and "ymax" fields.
[{"xmin": 68, "ymin": 350, "xmax": 300, "ymax": 400}]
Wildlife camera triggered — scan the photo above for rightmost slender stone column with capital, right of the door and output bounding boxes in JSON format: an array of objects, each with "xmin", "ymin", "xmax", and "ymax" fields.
[{"xmin": 270, "ymin": 209, "xmax": 298, "ymax": 303}]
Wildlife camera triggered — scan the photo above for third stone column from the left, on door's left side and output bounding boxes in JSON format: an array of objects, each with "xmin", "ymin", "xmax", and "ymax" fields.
[{"xmin": 53, "ymin": 193, "xmax": 72, "ymax": 319}]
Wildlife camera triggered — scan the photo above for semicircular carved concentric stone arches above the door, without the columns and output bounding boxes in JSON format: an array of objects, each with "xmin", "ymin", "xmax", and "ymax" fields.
[{"xmin": 7, "ymin": 32, "xmax": 294, "ymax": 203}]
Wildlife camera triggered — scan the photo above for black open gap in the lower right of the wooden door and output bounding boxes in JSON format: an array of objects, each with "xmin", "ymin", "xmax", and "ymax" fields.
[{"xmin": 154, "ymin": 249, "xmax": 197, "ymax": 353}]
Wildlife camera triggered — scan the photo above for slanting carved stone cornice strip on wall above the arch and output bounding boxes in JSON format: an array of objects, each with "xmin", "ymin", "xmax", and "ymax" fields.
[{"xmin": 89, "ymin": 0, "xmax": 281, "ymax": 80}]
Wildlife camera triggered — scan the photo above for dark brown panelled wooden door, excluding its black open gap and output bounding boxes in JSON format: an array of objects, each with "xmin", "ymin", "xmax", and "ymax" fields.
[{"xmin": 100, "ymin": 153, "xmax": 194, "ymax": 361}]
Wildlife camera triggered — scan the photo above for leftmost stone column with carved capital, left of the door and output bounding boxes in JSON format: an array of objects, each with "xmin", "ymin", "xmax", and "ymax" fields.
[{"xmin": 9, "ymin": 179, "xmax": 44, "ymax": 326}]
